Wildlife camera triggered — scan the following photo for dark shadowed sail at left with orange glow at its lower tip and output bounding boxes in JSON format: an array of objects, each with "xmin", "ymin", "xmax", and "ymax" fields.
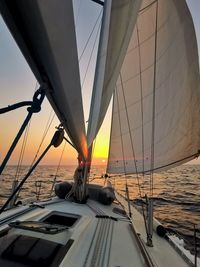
[{"xmin": 0, "ymin": 0, "xmax": 87, "ymax": 158}]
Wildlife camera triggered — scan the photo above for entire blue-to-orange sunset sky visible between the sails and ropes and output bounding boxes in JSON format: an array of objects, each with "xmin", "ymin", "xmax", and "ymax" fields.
[{"xmin": 0, "ymin": 0, "xmax": 200, "ymax": 168}]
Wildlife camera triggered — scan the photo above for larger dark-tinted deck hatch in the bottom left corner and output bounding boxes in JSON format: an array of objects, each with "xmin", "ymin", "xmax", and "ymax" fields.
[{"xmin": 0, "ymin": 234, "xmax": 73, "ymax": 267}]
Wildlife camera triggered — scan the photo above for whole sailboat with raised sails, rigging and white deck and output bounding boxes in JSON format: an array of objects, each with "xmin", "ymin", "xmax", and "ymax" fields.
[{"xmin": 0, "ymin": 0, "xmax": 200, "ymax": 267}]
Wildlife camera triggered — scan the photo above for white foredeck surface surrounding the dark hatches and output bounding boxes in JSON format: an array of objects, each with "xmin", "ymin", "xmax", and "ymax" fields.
[{"xmin": 0, "ymin": 196, "xmax": 193, "ymax": 267}]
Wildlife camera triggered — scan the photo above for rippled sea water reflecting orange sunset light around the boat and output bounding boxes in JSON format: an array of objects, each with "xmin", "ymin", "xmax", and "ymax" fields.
[{"xmin": 0, "ymin": 165, "xmax": 200, "ymax": 257}]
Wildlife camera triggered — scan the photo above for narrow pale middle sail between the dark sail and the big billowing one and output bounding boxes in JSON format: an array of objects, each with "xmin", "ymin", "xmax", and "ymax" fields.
[{"xmin": 87, "ymin": 0, "xmax": 141, "ymax": 146}]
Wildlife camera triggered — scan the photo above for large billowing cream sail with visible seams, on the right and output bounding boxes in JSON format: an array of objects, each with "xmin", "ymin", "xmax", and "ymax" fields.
[{"xmin": 107, "ymin": 0, "xmax": 200, "ymax": 173}]
